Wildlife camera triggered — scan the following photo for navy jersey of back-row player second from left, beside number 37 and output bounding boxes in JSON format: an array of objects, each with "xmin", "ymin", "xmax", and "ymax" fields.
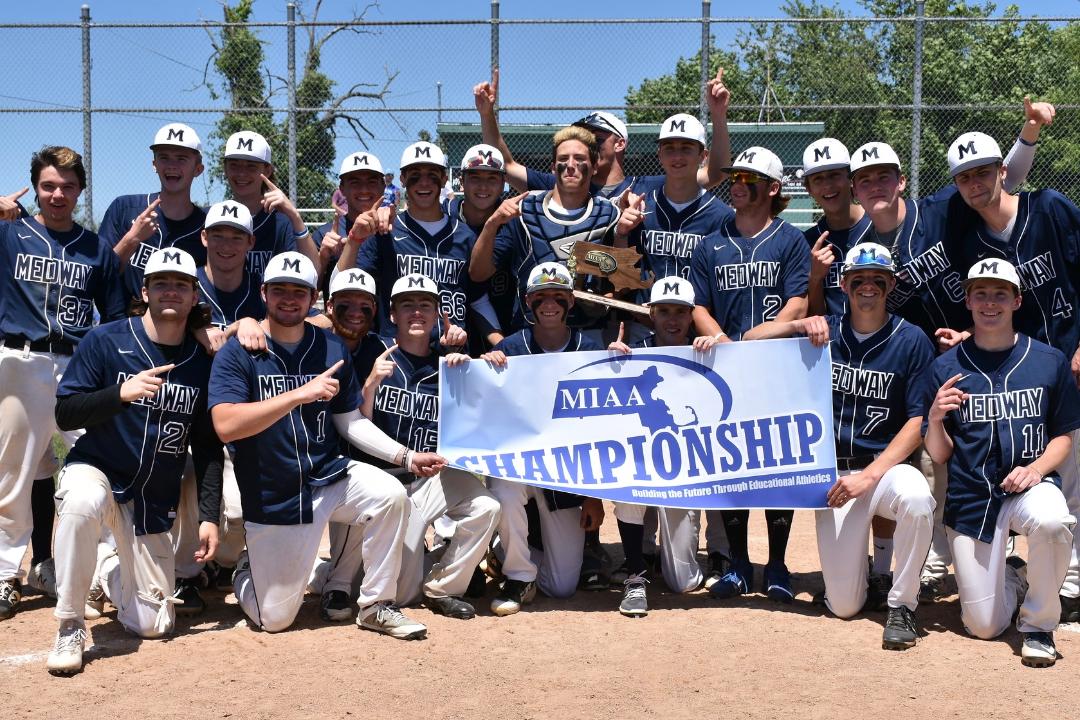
[{"xmin": 97, "ymin": 192, "xmax": 206, "ymax": 298}]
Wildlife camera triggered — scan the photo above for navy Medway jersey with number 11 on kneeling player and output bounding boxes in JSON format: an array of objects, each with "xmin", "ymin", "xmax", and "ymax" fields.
[{"xmin": 922, "ymin": 334, "xmax": 1080, "ymax": 542}]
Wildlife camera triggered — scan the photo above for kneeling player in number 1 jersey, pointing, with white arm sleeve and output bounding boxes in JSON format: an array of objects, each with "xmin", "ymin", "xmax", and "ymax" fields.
[{"xmin": 210, "ymin": 252, "xmax": 444, "ymax": 639}]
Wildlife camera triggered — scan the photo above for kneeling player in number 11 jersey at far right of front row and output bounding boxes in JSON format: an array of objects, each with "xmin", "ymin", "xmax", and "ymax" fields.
[{"xmin": 923, "ymin": 258, "xmax": 1080, "ymax": 667}]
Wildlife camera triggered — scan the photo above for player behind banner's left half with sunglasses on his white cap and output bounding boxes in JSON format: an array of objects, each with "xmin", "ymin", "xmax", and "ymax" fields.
[{"xmin": 481, "ymin": 262, "xmax": 604, "ymax": 615}]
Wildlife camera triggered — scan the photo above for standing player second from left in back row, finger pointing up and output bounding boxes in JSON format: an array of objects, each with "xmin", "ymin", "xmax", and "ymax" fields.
[{"xmin": 98, "ymin": 123, "xmax": 206, "ymax": 298}]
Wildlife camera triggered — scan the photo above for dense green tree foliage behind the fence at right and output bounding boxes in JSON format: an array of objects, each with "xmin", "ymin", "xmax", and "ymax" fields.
[{"xmin": 626, "ymin": 0, "xmax": 1080, "ymax": 198}]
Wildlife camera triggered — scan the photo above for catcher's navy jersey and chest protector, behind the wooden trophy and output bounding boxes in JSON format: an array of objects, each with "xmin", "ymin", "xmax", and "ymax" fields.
[{"xmin": 491, "ymin": 191, "xmax": 619, "ymax": 330}]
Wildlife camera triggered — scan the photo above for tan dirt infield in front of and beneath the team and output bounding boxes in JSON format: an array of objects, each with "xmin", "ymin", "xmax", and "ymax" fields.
[{"xmin": 0, "ymin": 507, "xmax": 1080, "ymax": 720}]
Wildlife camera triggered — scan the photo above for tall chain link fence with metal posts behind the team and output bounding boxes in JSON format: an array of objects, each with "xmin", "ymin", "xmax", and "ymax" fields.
[{"xmin": 0, "ymin": 0, "xmax": 1080, "ymax": 231}]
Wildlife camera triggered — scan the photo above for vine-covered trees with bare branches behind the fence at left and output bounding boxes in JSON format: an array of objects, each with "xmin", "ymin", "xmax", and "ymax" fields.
[{"xmin": 205, "ymin": 0, "xmax": 397, "ymax": 206}]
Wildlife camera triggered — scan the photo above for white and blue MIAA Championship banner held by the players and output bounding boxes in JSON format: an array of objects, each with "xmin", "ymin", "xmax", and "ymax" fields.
[{"xmin": 438, "ymin": 339, "xmax": 836, "ymax": 508}]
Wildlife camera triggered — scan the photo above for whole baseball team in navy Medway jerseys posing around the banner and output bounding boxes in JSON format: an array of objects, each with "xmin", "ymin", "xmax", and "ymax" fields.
[{"xmin": 0, "ymin": 70, "xmax": 1080, "ymax": 675}]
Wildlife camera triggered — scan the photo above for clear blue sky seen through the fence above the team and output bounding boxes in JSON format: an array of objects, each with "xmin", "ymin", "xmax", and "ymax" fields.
[{"xmin": 0, "ymin": 0, "xmax": 1080, "ymax": 218}]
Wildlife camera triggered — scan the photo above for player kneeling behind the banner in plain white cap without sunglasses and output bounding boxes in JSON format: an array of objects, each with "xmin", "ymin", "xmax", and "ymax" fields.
[{"xmin": 608, "ymin": 275, "xmax": 717, "ymax": 617}]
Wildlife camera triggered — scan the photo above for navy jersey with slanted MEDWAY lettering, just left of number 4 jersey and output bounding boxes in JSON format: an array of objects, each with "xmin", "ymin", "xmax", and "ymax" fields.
[{"xmin": 865, "ymin": 185, "xmax": 978, "ymax": 337}]
